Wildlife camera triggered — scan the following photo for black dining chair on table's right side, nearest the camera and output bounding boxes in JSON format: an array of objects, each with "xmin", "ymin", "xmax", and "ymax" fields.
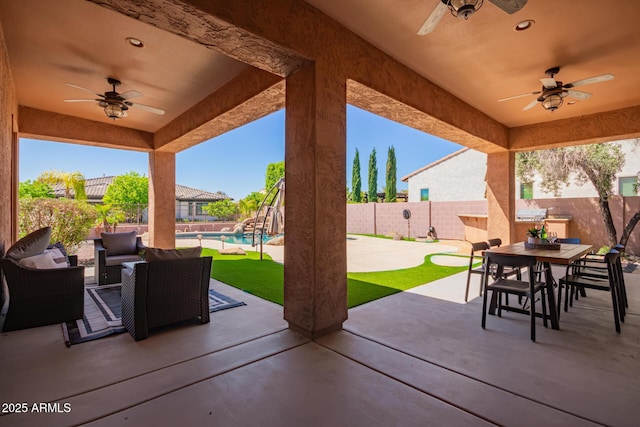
[{"xmin": 558, "ymin": 250, "xmax": 626, "ymax": 333}]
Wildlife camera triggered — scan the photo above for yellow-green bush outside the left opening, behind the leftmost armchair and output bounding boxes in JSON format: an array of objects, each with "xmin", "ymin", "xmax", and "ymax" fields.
[{"xmin": 18, "ymin": 198, "xmax": 97, "ymax": 254}]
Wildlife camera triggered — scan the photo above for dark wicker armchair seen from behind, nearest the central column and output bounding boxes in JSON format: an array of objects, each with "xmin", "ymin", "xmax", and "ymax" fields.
[{"xmin": 122, "ymin": 257, "xmax": 212, "ymax": 341}]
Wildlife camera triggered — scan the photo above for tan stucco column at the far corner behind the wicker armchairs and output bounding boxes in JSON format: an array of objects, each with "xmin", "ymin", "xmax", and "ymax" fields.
[{"xmin": 149, "ymin": 151, "xmax": 176, "ymax": 249}]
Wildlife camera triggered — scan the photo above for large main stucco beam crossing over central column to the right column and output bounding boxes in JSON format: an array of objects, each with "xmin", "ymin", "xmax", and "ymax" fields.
[{"xmin": 96, "ymin": 0, "xmax": 508, "ymax": 153}]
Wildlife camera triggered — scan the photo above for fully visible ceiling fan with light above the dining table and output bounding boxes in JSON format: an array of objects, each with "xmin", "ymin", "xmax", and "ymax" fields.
[{"xmin": 498, "ymin": 67, "xmax": 613, "ymax": 111}]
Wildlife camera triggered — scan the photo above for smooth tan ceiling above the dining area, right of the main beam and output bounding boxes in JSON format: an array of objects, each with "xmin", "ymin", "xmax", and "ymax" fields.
[{"xmin": 307, "ymin": 0, "xmax": 640, "ymax": 127}]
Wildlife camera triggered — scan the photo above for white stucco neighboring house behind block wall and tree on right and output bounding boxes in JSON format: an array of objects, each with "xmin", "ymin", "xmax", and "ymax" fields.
[{"xmin": 402, "ymin": 140, "xmax": 640, "ymax": 202}]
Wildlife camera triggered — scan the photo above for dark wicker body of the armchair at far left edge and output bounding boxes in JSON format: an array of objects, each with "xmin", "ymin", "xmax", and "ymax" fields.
[{"xmin": 0, "ymin": 256, "xmax": 84, "ymax": 331}]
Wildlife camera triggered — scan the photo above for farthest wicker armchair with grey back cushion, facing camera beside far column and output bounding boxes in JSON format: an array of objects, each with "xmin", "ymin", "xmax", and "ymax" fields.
[{"xmin": 93, "ymin": 231, "xmax": 145, "ymax": 285}]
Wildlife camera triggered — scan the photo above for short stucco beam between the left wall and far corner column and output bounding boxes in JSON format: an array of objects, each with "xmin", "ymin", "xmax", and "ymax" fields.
[{"xmin": 18, "ymin": 106, "xmax": 153, "ymax": 152}]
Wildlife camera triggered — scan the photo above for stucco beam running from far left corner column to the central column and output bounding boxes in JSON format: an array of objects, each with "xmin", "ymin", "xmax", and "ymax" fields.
[{"xmin": 154, "ymin": 68, "xmax": 285, "ymax": 153}]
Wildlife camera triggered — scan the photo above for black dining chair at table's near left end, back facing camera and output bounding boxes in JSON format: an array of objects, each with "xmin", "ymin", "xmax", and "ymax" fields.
[{"xmin": 482, "ymin": 252, "xmax": 547, "ymax": 341}]
